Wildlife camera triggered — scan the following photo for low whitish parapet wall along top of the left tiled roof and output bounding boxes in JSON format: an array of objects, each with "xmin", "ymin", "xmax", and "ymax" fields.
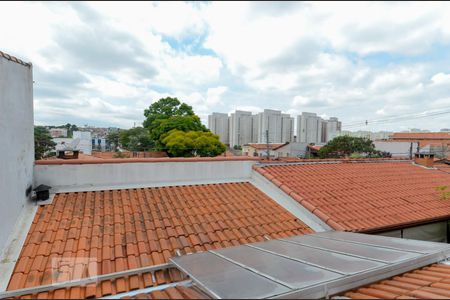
[{"xmin": 35, "ymin": 160, "xmax": 257, "ymax": 192}]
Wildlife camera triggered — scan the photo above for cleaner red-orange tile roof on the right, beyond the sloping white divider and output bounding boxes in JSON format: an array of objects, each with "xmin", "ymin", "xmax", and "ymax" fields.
[{"xmin": 254, "ymin": 162, "xmax": 450, "ymax": 232}]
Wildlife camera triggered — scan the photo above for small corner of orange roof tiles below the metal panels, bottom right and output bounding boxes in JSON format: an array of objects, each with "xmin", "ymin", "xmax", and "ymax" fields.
[{"xmin": 345, "ymin": 264, "xmax": 450, "ymax": 299}]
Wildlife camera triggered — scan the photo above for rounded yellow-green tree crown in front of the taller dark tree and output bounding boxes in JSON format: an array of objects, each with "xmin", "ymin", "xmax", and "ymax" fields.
[{"xmin": 162, "ymin": 129, "xmax": 226, "ymax": 157}]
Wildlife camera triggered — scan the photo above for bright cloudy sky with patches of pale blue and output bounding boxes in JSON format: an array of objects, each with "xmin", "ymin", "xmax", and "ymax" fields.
[{"xmin": 0, "ymin": 2, "xmax": 450, "ymax": 131}]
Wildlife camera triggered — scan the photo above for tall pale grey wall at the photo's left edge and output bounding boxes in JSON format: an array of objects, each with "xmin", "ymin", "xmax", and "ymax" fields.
[{"xmin": 0, "ymin": 55, "xmax": 34, "ymax": 254}]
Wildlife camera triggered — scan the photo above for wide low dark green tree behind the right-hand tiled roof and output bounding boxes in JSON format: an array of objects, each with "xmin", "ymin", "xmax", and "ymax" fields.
[{"xmin": 319, "ymin": 135, "xmax": 381, "ymax": 158}]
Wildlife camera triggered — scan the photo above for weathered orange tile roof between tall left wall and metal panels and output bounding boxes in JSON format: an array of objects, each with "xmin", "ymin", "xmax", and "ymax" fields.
[{"xmin": 8, "ymin": 183, "xmax": 312, "ymax": 298}]
